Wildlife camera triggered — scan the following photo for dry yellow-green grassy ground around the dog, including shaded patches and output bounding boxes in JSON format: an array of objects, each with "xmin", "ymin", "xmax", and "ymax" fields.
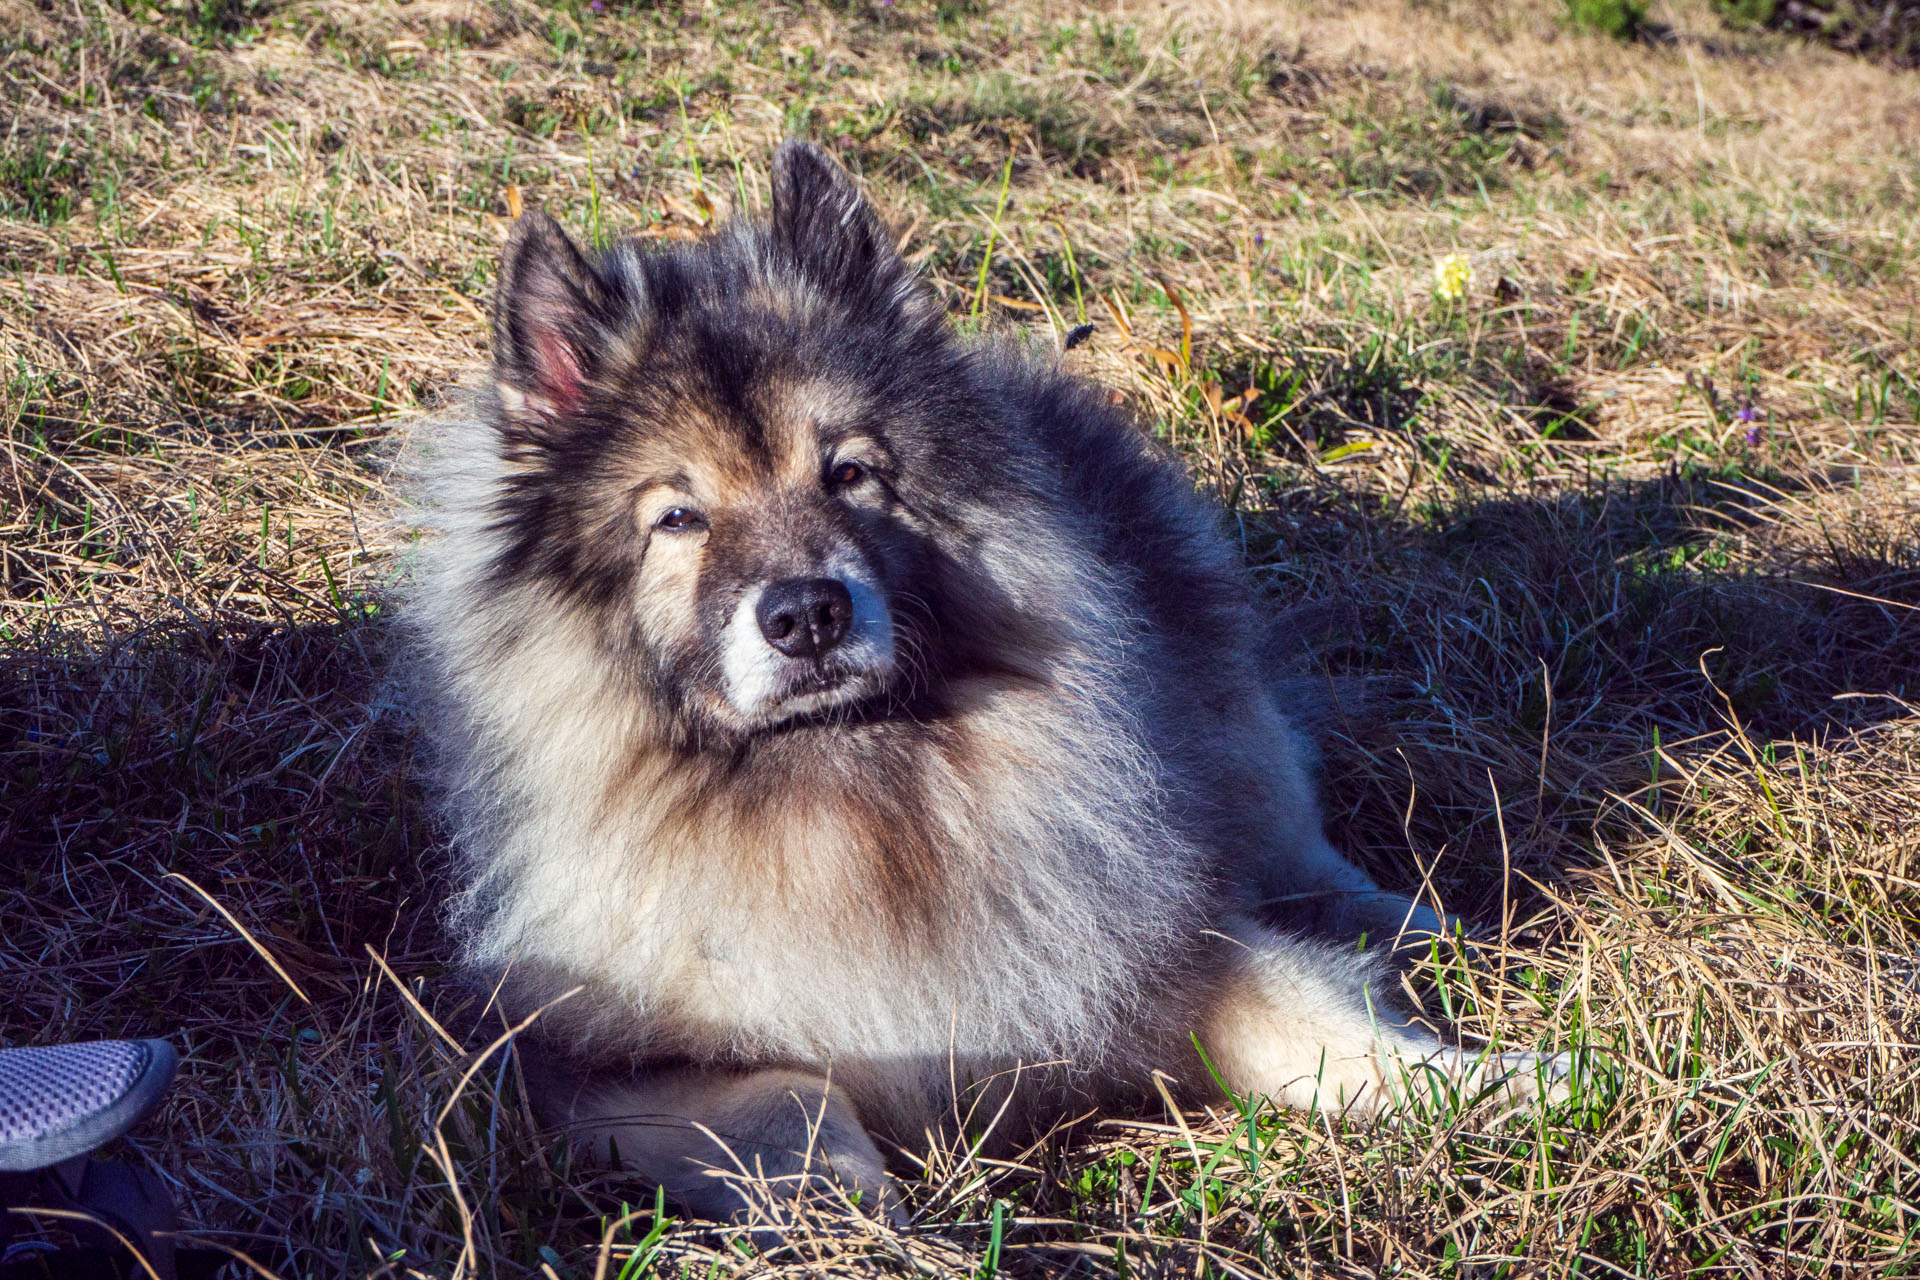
[{"xmin": 0, "ymin": 0, "xmax": 1920, "ymax": 1276}]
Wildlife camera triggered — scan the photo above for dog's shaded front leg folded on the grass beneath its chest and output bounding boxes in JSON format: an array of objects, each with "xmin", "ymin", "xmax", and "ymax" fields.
[{"xmin": 520, "ymin": 1050, "xmax": 900, "ymax": 1226}]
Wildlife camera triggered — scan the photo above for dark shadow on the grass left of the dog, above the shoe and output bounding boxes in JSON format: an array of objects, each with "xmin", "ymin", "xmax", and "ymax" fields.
[{"xmin": 0, "ymin": 608, "xmax": 468, "ymax": 1274}]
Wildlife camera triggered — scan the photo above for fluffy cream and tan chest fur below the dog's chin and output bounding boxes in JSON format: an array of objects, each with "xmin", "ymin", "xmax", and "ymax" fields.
[{"xmin": 441, "ymin": 617, "xmax": 1204, "ymax": 1063}]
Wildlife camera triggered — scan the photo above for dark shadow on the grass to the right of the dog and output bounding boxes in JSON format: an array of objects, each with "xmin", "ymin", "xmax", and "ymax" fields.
[{"xmin": 1254, "ymin": 474, "xmax": 1920, "ymax": 917}]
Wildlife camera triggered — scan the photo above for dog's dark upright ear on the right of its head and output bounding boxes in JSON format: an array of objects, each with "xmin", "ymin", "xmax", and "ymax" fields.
[{"xmin": 774, "ymin": 142, "xmax": 906, "ymax": 303}]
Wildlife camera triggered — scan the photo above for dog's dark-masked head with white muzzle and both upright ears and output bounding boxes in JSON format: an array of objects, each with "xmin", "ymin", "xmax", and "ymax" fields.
[{"xmin": 474, "ymin": 144, "xmax": 981, "ymax": 737}]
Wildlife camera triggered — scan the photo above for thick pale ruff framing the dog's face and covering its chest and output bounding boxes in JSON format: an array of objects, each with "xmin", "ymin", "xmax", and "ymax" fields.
[{"xmin": 401, "ymin": 210, "xmax": 1208, "ymax": 1069}]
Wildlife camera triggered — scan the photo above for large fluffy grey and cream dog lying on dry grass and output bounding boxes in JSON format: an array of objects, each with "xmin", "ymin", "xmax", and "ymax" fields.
[{"xmin": 403, "ymin": 144, "xmax": 1551, "ymax": 1217}]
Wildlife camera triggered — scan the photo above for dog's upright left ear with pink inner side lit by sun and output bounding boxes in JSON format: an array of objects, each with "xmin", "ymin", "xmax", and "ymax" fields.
[{"xmin": 493, "ymin": 211, "xmax": 611, "ymax": 418}]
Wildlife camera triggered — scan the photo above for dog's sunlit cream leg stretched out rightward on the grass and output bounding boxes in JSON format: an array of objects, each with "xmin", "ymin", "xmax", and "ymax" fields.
[{"xmin": 1198, "ymin": 925, "xmax": 1571, "ymax": 1115}]
